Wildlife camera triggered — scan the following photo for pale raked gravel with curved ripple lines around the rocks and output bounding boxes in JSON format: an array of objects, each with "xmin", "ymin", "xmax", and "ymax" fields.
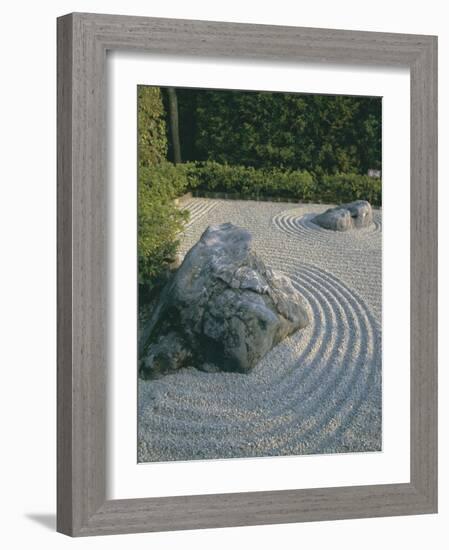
[{"xmin": 138, "ymin": 199, "xmax": 382, "ymax": 462}]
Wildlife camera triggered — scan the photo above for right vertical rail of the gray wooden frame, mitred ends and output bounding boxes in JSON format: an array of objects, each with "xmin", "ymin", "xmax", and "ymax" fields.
[{"xmin": 410, "ymin": 35, "xmax": 438, "ymax": 510}]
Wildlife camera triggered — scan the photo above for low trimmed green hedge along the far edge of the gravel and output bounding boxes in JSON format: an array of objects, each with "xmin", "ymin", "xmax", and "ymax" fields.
[{"xmin": 184, "ymin": 161, "xmax": 382, "ymax": 209}]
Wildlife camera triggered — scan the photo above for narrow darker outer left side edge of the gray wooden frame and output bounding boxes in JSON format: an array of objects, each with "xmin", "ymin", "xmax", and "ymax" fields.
[{"xmin": 57, "ymin": 17, "xmax": 73, "ymax": 533}]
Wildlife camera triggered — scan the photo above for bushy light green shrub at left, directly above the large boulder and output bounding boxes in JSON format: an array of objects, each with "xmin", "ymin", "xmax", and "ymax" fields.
[{"xmin": 138, "ymin": 161, "xmax": 188, "ymax": 288}]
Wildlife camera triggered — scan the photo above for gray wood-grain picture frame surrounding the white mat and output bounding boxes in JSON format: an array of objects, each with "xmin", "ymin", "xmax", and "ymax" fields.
[{"xmin": 57, "ymin": 13, "xmax": 437, "ymax": 536}]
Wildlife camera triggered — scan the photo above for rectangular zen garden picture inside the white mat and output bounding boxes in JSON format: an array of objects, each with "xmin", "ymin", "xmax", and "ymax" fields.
[{"xmin": 136, "ymin": 85, "xmax": 383, "ymax": 462}]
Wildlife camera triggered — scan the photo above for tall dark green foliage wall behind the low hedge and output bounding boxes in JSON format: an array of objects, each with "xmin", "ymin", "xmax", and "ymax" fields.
[{"xmin": 177, "ymin": 88, "xmax": 381, "ymax": 175}]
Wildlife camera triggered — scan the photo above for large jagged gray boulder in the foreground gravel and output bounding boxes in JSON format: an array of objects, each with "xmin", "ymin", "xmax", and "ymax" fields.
[{"xmin": 139, "ymin": 223, "xmax": 308, "ymax": 378}]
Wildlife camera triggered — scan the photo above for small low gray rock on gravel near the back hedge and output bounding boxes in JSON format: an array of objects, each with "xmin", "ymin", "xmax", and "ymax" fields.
[{"xmin": 312, "ymin": 201, "xmax": 373, "ymax": 231}]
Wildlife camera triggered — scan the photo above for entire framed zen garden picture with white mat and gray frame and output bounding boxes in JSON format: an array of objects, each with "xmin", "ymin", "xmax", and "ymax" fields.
[{"xmin": 57, "ymin": 13, "xmax": 437, "ymax": 536}]
